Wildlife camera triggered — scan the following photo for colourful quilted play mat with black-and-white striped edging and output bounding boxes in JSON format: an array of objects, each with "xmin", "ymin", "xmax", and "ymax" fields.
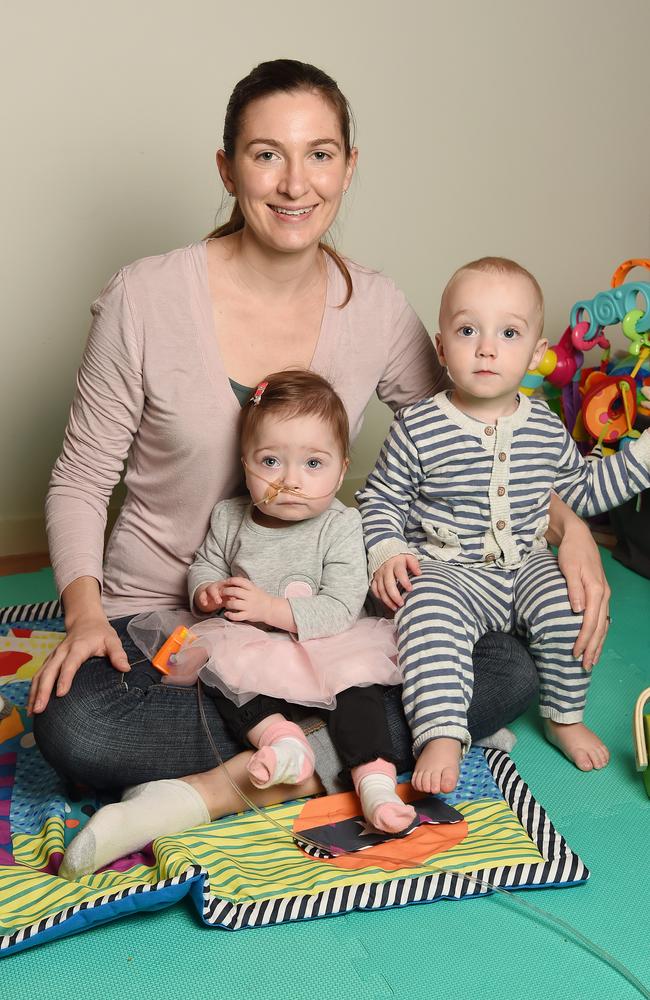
[{"xmin": 0, "ymin": 602, "xmax": 589, "ymax": 955}]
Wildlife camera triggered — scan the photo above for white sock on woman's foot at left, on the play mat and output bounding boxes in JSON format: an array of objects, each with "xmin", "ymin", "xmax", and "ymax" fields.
[{"xmin": 59, "ymin": 778, "xmax": 210, "ymax": 881}]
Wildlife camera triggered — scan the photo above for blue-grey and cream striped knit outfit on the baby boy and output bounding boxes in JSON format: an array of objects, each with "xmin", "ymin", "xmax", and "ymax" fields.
[{"xmin": 357, "ymin": 391, "xmax": 650, "ymax": 756}]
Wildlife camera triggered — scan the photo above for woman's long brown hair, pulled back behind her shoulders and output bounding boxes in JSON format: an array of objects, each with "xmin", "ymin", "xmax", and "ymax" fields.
[{"xmin": 206, "ymin": 59, "xmax": 353, "ymax": 306}]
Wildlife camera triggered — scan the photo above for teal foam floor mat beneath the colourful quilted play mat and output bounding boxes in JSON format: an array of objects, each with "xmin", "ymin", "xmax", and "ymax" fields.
[{"xmin": 0, "ymin": 553, "xmax": 650, "ymax": 1000}]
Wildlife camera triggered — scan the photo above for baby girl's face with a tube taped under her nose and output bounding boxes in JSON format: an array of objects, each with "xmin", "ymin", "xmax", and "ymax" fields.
[{"xmin": 242, "ymin": 415, "xmax": 348, "ymax": 527}]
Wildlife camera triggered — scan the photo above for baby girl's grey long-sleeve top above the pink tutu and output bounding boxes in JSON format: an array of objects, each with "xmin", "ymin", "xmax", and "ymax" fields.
[{"xmin": 188, "ymin": 496, "xmax": 368, "ymax": 641}]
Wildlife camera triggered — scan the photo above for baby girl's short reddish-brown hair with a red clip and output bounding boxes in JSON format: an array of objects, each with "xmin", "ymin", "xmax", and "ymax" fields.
[{"xmin": 239, "ymin": 368, "xmax": 350, "ymax": 458}]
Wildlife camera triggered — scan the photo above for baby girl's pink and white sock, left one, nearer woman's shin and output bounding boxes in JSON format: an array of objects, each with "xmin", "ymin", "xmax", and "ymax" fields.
[{"xmin": 247, "ymin": 719, "xmax": 315, "ymax": 788}]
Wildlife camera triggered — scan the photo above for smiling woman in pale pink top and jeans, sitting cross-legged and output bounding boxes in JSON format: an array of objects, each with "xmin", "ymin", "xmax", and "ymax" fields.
[{"xmin": 29, "ymin": 60, "xmax": 609, "ymax": 818}]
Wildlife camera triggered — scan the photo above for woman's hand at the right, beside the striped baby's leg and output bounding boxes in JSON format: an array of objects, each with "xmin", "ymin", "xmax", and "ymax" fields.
[{"xmin": 550, "ymin": 497, "xmax": 611, "ymax": 670}]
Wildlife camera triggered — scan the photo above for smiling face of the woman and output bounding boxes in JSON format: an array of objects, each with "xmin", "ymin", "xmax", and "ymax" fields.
[{"xmin": 217, "ymin": 90, "xmax": 357, "ymax": 253}]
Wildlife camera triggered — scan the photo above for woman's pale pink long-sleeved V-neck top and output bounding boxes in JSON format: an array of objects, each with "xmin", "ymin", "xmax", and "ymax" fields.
[{"xmin": 46, "ymin": 242, "xmax": 444, "ymax": 616}]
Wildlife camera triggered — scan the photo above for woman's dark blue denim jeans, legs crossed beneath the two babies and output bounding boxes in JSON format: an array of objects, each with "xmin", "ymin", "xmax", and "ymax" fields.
[{"xmin": 33, "ymin": 617, "xmax": 537, "ymax": 789}]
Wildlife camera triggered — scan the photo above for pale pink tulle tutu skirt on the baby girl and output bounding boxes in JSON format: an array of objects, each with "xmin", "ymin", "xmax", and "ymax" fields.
[{"xmin": 128, "ymin": 612, "xmax": 402, "ymax": 709}]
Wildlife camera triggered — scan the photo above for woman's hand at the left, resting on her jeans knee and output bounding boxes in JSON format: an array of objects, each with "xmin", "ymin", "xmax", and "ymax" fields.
[{"xmin": 27, "ymin": 614, "xmax": 131, "ymax": 715}]
